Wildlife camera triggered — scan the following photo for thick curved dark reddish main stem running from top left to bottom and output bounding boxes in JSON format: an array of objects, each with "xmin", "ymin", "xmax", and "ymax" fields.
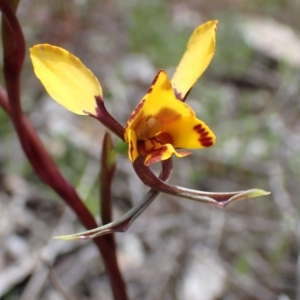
[{"xmin": 0, "ymin": 0, "xmax": 128, "ymax": 300}]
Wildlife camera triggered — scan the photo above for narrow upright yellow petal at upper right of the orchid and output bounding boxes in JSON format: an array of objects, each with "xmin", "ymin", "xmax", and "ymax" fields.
[{"xmin": 171, "ymin": 20, "xmax": 218, "ymax": 100}]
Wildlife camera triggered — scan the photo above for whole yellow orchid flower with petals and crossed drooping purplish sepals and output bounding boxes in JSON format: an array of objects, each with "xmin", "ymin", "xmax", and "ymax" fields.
[{"xmin": 30, "ymin": 20, "xmax": 269, "ymax": 239}]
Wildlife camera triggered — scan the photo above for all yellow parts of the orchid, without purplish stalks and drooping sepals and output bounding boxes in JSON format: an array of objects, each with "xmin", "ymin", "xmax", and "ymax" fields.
[{"xmin": 30, "ymin": 21, "xmax": 217, "ymax": 165}]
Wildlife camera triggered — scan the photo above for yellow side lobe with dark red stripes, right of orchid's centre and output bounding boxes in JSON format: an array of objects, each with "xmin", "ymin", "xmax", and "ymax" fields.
[{"xmin": 163, "ymin": 117, "xmax": 216, "ymax": 149}]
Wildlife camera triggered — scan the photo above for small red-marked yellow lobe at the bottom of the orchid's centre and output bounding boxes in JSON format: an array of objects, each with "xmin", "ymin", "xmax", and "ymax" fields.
[{"xmin": 144, "ymin": 144, "xmax": 191, "ymax": 166}]
